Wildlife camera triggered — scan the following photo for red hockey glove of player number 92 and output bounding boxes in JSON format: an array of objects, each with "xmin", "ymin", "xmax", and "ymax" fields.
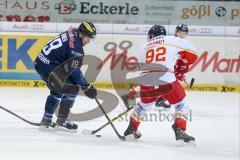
[{"xmin": 174, "ymin": 59, "xmax": 189, "ymax": 81}]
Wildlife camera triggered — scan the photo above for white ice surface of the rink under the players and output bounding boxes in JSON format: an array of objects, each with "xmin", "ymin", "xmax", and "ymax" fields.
[{"xmin": 0, "ymin": 88, "xmax": 240, "ymax": 160}]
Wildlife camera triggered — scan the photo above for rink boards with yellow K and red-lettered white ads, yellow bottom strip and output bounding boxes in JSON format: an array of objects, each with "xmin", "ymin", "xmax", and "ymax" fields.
[{"xmin": 0, "ymin": 32, "xmax": 240, "ymax": 92}]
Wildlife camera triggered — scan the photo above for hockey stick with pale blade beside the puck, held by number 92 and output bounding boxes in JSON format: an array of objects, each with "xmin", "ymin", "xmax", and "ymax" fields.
[{"xmin": 82, "ymin": 106, "xmax": 133, "ymax": 135}]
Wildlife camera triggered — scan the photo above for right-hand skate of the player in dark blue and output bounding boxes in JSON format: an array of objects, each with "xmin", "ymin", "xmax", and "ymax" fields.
[{"xmin": 54, "ymin": 120, "xmax": 78, "ymax": 133}]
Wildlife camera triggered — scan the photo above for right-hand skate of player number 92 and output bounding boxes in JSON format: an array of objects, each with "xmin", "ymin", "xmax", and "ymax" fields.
[{"xmin": 172, "ymin": 124, "xmax": 195, "ymax": 145}]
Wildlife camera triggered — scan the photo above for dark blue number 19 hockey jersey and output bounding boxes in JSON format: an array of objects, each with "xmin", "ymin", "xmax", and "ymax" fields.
[{"xmin": 34, "ymin": 27, "xmax": 88, "ymax": 86}]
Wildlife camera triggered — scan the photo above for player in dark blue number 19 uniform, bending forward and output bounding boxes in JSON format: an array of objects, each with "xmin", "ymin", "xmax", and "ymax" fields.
[{"xmin": 34, "ymin": 22, "xmax": 97, "ymax": 132}]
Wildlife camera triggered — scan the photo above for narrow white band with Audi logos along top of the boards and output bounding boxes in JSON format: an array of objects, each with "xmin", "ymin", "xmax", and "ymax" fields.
[{"xmin": 0, "ymin": 22, "xmax": 240, "ymax": 37}]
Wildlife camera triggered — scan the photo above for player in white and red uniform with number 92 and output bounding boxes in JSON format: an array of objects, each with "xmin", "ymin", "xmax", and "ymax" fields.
[{"xmin": 124, "ymin": 25, "xmax": 197, "ymax": 143}]
